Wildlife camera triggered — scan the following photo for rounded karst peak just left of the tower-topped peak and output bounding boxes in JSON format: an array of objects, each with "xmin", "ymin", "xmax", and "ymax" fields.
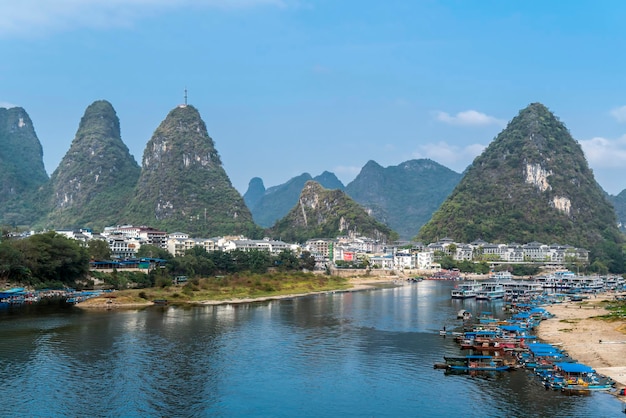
[{"xmin": 45, "ymin": 100, "xmax": 140, "ymax": 229}]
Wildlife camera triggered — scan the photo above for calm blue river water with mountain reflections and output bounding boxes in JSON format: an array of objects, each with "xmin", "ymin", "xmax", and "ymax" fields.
[{"xmin": 0, "ymin": 281, "xmax": 622, "ymax": 417}]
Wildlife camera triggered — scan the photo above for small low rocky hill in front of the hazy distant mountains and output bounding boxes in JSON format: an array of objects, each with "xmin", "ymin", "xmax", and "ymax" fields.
[{"xmin": 269, "ymin": 181, "xmax": 397, "ymax": 242}]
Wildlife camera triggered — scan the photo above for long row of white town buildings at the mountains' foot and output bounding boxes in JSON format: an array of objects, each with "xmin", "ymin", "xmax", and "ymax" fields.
[{"xmin": 50, "ymin": 225, "xmax": 589, "ymax": 271}]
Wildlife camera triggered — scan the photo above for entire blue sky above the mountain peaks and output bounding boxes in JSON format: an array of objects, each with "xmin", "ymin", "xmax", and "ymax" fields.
[{"xmin": 0, "ymin": 0, "xmax": 626, "ymax": 194}]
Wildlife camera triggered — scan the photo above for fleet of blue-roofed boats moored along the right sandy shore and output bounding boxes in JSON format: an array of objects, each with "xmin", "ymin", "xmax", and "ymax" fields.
[{"xmin": 435, "ymin": 272, "xmax": 625, "ymax": 393}]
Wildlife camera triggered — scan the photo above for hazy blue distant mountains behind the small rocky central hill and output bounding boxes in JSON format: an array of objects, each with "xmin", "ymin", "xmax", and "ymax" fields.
[{"xmin": 244, "ymin": 159, "xmax": 462, "ymax": 239}]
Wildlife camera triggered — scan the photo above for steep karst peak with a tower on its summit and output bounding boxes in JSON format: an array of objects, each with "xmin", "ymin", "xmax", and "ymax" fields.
[{"xmin": 125, "ymin": 106, "xmax": 259, "ymax": 236}]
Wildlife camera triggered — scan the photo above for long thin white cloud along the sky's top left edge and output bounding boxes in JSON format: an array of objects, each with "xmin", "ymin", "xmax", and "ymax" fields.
[{"xmin": 0, "ymin": 0, "xmax": 288, "ymax": 37}]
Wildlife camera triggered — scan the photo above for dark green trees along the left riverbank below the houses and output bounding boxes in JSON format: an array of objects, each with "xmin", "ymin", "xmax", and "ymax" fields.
[{"xmin": 0, "ymin": 232, "xmax": 315, "ymax": 288}]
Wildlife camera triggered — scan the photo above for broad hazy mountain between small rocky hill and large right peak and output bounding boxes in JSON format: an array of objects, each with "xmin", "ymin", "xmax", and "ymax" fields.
[{"xmin": 346, "ymin": 159, "xmax": 462, "ymax": 239}]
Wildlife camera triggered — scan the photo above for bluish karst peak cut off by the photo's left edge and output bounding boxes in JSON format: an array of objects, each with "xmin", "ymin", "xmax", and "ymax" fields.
[{"xmin": 0, "ymin": 107, "xmax": 48, "ymax": 227}]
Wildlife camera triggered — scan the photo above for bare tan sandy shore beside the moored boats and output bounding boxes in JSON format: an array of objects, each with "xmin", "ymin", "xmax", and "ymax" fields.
[{"xmin": 537, "ymin": 294, "xmax": 626, "ymax": 388}]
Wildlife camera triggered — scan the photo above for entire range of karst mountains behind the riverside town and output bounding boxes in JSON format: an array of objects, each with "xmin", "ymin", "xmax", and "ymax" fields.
[{"xmin": 0, "ymin": 100, "xmax": 626, "ymax": 268}]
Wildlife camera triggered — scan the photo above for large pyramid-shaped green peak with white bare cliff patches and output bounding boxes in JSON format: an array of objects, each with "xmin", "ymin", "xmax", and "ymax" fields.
[{"xmin": 418, "ymin": 103, "xmax": 623, "ymax": 271}]
